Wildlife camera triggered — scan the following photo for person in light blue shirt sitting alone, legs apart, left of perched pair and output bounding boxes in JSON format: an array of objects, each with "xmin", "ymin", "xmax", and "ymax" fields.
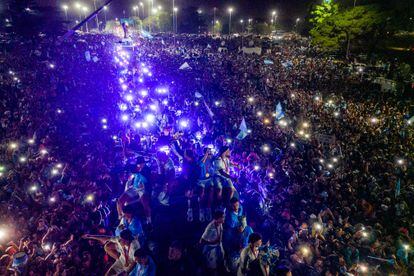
[{"xmin": 117, "ymin": 156, "xmax": 151, "ymax": 223}]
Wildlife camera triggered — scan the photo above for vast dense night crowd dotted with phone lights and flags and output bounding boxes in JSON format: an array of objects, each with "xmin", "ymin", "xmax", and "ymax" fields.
[{"xmin": 0, "ymin": 29, "xmax": 414, "ymax": 276}]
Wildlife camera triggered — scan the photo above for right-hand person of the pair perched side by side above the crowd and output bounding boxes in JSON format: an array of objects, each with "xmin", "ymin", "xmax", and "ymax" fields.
[{"xmin": 214, "ymin": 146, "xmax": 235, "ymax": 205}]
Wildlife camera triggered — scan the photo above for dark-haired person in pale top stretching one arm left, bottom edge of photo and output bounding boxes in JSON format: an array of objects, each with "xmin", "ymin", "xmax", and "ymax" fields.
[{"xmin": 82, "ymin": 229, "xmax": 141, "ymax": 276}]
